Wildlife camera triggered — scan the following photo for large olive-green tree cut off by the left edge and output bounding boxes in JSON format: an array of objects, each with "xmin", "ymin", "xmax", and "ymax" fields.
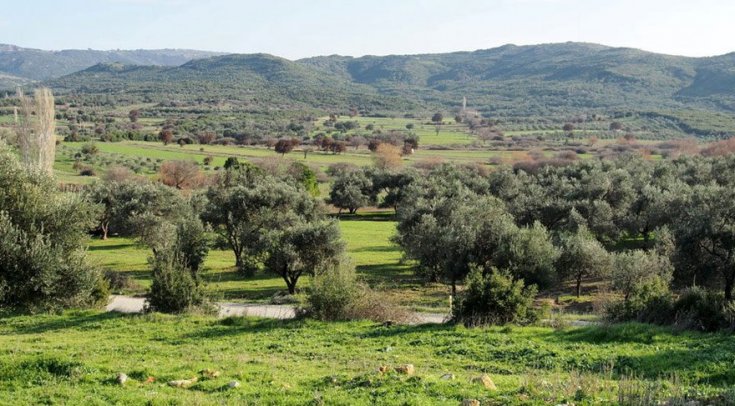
[{"xmin": 0, "ymin": 151, "xmax": 107, "ymax": 311}]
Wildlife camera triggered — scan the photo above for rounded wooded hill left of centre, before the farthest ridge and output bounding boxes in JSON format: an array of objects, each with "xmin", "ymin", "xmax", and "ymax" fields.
[{"xmin": 47, "ymin": 54, "xmax": 417, "ymax": 110}]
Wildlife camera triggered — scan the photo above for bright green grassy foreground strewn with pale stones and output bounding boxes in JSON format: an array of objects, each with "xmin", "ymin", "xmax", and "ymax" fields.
[{"xmin": 0, "ymin": 312, "xmax": 735, "ymax": 405}]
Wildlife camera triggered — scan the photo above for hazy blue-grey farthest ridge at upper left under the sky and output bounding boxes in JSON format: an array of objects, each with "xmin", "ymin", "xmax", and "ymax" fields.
[{"xmin": 0, "ymin": 44, "xmax": 222, "ymax": 80}]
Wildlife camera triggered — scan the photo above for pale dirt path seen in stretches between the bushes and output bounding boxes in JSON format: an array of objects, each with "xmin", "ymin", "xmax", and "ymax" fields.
[{"xmin": 106, "ymin": 295, "xmax": 446, "ymax": 324}]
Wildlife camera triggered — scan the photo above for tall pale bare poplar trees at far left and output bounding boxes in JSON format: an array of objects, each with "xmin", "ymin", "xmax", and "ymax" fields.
[{"xmin": 16, "ymin": 87, "xmax": 56, "ymax": 175}]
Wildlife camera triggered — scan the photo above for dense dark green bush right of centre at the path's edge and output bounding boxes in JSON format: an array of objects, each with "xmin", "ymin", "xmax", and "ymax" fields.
[{"xmin": 452, "ymin": 269, "xmax": 537, "ymax": 327}]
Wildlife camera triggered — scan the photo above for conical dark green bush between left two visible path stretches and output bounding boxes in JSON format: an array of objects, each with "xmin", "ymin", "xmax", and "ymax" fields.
[{"xmin": 148, "ymin": 254, "xmax": 205, "ymax": 313}]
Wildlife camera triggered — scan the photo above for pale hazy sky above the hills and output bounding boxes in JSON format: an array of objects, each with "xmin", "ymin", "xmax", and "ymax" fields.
[{"xmin": 0, "ymin": 0, "xmax": 735, "ymax": 59}]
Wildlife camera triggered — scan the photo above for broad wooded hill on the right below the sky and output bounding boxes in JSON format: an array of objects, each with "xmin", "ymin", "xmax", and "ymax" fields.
[{"xmin": 299, "ymin": 43, "xmax": 735, "ymax": 115}]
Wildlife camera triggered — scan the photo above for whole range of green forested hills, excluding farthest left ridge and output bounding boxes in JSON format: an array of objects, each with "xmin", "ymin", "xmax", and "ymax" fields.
[{"xmin": 38, "ymin": 43, "xmax": 735, "ymax": 116}]
